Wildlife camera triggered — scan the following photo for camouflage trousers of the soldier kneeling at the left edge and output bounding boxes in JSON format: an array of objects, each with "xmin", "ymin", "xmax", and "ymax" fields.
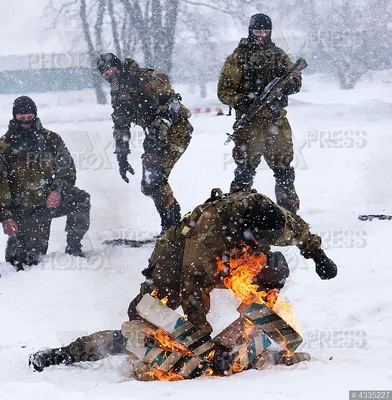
[{"xmin": 5, "ymin": 187, "xmax": 90, "ymax": 265}]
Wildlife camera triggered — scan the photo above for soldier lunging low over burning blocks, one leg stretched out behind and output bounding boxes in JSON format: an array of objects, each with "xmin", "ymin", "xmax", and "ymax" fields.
[{"xmin": 30, "ymin": 190, "xmax": 337, "ymax": 371}]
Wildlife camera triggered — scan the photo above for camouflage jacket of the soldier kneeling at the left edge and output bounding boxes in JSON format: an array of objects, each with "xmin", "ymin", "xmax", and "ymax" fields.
[{"xmin": 0, "ymin": 120, "xmax": 76, "ymax": 221}]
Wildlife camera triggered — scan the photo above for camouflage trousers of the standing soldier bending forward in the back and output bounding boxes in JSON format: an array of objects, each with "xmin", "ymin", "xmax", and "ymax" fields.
[{"xmin": 141, "ymin": 119, "xmax": 193, "ymax": 230}]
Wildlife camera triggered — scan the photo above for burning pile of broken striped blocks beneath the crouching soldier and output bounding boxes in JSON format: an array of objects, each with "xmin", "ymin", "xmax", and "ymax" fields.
[{"xmin": 122, "ymin": 294, "xmax": 310, "ymax": 380}]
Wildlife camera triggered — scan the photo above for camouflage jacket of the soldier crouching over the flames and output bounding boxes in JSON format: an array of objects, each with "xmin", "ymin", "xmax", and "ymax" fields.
[{"xmin": 151, "ymin": 190, "xmax": 321, "ymax": 331}]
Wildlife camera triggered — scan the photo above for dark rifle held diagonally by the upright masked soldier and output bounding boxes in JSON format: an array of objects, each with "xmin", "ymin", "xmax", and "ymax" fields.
[{"xmin": 225, "ymin": 58, "xmax": 308, "ymax": 145}]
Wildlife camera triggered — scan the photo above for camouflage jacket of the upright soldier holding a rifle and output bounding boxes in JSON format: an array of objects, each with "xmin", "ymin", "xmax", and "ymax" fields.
[{"xmin": 218, "ymin": 38, "xmax": 302, "ymax": 118}]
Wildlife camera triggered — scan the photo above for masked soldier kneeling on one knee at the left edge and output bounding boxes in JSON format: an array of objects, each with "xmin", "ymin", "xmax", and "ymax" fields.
[{"xmin": 0, "ymin": 96, "xmax": 90, "ymax": 270}]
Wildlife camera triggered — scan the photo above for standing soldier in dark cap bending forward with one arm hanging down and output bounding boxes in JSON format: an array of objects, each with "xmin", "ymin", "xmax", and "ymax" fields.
[{"xmin": 98, "ymin": 53, "xmax": 193, "ymax": 231}]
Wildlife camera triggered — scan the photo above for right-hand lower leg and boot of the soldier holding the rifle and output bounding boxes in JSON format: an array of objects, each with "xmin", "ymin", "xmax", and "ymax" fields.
[{"xmin": 274, "ymin": 167, "xmax": 299, "ymax": 214}]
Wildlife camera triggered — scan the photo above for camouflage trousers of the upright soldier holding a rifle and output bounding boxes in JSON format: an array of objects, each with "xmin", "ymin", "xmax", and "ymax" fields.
[{"xmin": 230, "ymin": 110, "xmax": 299, "ymax": 213}]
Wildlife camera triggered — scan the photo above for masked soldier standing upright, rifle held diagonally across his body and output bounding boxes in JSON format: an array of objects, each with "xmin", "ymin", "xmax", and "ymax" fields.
[{"xmin": 218, "ymin": 14, "xmax": 301, "ymax": 213}]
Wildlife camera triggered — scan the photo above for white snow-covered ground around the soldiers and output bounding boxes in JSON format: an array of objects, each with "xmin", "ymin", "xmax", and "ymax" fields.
[{"xmin": 0, "ymin": 76, "xmax": 392, "ymax": 400}]
